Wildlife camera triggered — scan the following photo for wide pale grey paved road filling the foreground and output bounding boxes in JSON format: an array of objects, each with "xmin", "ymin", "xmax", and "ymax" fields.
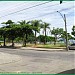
[{"xmin": 0, "ymin": 48, "xmax": 75, "ymax": 74}]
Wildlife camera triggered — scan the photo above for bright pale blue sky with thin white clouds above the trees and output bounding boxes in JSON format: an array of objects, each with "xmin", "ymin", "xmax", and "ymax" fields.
[{"xmin": 0, "ymin": 1, "xmax": 75, "ymax": 35}]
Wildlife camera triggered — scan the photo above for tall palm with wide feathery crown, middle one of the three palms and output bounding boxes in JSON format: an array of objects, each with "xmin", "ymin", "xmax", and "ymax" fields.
[{"xmin": 31, "ymin": 20, "xmax": 41, "ymax": 45}]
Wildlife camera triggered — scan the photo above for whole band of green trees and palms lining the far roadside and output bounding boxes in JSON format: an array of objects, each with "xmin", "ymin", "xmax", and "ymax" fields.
[{"xmin": 0, "ymin": 20, "xmax": 75, "ymax": 46}]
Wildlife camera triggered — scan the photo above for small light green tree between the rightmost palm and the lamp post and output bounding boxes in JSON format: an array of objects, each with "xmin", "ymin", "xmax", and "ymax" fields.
[{"xmin": 51, "ymin": 27, "xmax": 63, "ymax": 45}]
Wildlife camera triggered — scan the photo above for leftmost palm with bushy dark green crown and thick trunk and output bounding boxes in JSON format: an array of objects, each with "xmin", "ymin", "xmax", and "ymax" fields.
[{"xmin": 19, "ymin": 20, "xmax": 32, "ymax": 47}]
